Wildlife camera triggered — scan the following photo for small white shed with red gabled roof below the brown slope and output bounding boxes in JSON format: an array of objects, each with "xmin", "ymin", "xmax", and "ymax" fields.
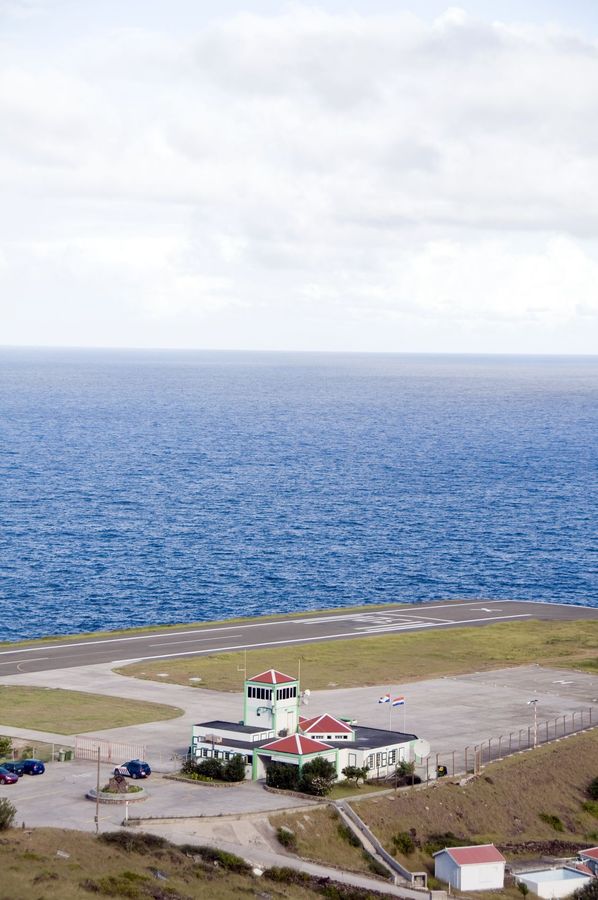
[{"xmin": 434, "ymin": 844, "xmax": 506, "ymax": 891}]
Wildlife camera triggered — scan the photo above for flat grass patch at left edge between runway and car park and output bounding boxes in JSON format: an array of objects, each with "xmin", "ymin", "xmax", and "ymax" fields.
[{"xmin": 0, "ymin": 685, "xmax": 183, "ymax": 734}]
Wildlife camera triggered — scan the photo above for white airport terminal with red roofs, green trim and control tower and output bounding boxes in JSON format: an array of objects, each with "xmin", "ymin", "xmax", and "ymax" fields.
[{"xmin": 190, "ymin": 669, "xmax": 416, "ymax": 779}]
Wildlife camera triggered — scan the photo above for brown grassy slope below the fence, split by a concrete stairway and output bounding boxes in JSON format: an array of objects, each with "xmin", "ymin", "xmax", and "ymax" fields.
[{"xmin": 270, "ymin": 730, "xmax": 598, "ymax": 884}]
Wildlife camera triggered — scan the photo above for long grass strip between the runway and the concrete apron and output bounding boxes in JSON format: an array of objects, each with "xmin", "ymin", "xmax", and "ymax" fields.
[{"xmin": 116, "ymin": 620, "xmax": 598, "ymax": 691}]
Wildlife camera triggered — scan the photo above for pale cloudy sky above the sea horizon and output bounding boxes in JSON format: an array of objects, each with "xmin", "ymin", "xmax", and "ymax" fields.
[{"xmin": 0, "ymin": 0, "xmax": 598, "ymax": 354}]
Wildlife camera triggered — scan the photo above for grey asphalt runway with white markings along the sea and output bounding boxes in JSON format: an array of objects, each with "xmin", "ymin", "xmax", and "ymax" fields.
[{"xmin": 0, "ymin": 600, "xmax": 598, "ymax": 676}]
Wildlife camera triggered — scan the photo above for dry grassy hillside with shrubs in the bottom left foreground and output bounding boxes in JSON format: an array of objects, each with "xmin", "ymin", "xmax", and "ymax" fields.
[{"xmin": 0, "ymin": 828, "xmax": 390, "ymax": 900}]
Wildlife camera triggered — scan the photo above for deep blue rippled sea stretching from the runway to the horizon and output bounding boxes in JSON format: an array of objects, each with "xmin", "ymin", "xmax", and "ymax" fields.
[{"xmin": 0, "ymin": 349, "xmax": 598, "ymax": 639}]
